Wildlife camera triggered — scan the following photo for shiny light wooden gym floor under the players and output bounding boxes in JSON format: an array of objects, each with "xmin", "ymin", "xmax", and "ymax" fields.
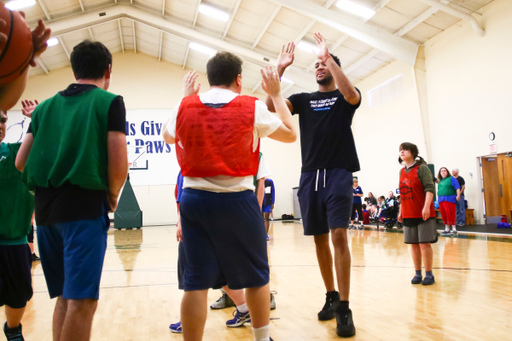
[{"xmin": 4, "ymin": 222, "xmax": 512, "ymax": 341}]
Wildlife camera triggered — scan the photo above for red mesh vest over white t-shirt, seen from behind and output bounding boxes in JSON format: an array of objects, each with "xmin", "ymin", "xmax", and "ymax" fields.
[{"xmin": 176, "ymin": 96, "xmax": 260, "ymax": 178}]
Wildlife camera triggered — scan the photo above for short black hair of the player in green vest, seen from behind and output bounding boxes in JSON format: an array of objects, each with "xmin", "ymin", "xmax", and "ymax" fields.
[{"xmin": 70, "ymin": 40, "xmax": 112, "ymax": 79}]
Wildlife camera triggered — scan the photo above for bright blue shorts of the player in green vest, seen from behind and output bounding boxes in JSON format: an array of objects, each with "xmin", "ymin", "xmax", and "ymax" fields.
[{"xmin": 37, "ymin": 213, "xmax": 110, "ymax": 300}]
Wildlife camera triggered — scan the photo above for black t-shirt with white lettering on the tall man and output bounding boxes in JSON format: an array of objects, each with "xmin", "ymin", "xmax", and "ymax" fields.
[{"xmin": 288, "ymin": 89, "xmax": 361, "ymax": 172}]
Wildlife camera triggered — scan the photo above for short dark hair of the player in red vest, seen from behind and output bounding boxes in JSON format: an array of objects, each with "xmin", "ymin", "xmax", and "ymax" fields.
[{"xmin": 206, "ymin": 51, "xmax": 243, "ymax": 86}]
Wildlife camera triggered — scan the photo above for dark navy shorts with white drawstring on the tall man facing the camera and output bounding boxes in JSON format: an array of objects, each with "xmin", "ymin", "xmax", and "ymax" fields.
[{"xmin": 297, "ymin": 168, "xmax": 353, "ymax": 236}]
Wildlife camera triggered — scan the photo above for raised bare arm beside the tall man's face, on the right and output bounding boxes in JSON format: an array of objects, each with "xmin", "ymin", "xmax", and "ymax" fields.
[{"xmin": 315, "ymin": 33, "xmax": 361, "ymax": 105}]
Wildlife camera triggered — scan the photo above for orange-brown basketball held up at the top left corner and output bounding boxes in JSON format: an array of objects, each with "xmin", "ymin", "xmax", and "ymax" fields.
[{"xmin": 0, "ymin": 2, "xmax": 33, "ymax": 84}]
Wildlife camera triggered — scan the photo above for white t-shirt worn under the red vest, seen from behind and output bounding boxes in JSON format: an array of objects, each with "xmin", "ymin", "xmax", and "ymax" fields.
[{"xmin": 166, "ymin": 88, "xmax": 282, "ymax": 192}]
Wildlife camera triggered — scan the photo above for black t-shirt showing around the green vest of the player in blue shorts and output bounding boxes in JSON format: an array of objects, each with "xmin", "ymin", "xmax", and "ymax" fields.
[{"xmin": 28, "ymin": 84, "xmax": 126, "ymax": 225}]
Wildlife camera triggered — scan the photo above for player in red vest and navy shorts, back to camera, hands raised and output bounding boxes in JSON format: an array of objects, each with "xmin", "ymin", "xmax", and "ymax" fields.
[{"xmin": 163, "ymin": 52, "xmax": 297, "ymax": 341}]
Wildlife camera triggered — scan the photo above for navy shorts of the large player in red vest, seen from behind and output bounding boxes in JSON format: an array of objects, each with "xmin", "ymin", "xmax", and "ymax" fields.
[{"xmin": 180, "ymin": 188, "xmax": 269, "ymax": 291}]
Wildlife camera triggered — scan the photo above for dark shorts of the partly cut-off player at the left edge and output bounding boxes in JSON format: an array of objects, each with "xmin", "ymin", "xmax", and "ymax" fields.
[{"xmin": 0, "ymin": 244, "xmax": 33, "ymax": 309}]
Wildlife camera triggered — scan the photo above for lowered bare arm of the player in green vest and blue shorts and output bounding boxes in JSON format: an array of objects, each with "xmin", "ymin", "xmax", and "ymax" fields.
[{"xmin": 107, "ymin": 131, "xmax": 128, "ymax": 212}]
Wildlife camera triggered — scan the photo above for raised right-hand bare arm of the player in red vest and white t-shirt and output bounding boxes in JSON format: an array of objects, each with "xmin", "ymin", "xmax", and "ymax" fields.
[{"xmin": 261, "ymin": 66, "xmax": 297, "ymax": 143}]
